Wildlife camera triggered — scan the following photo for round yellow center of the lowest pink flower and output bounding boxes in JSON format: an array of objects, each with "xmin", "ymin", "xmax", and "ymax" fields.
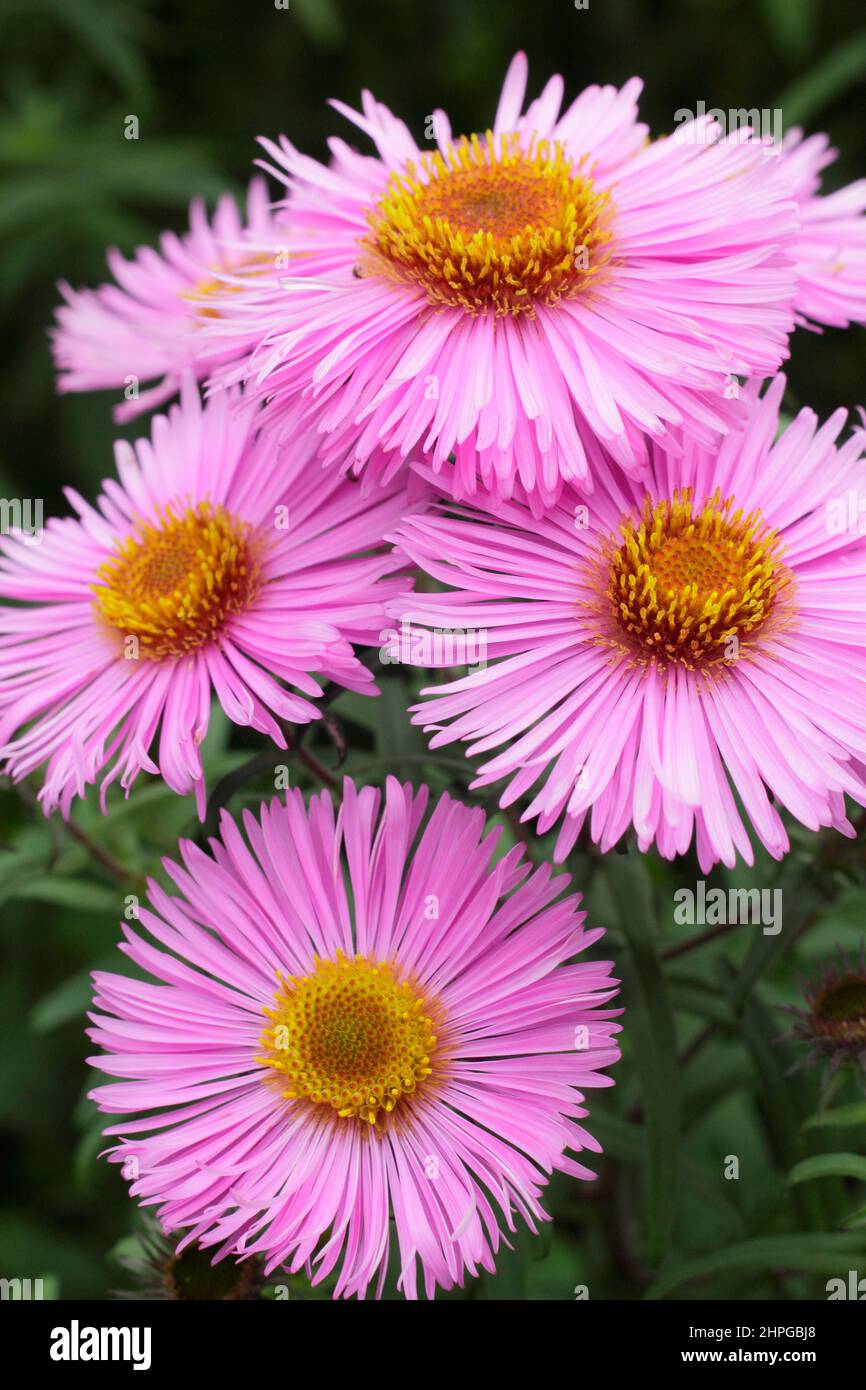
[{"xmin": 259, "ymin": 951, "xmax": 436, "ymax": 1125}]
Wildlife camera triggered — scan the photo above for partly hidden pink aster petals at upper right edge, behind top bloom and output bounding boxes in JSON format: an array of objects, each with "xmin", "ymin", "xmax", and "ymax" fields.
[{"xmin": 783, "ymin": 129, "xmax": 866, "ymax": 328}]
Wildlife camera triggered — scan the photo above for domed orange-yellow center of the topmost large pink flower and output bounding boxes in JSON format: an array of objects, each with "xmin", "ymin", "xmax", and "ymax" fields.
[{"xmin": 361, "ymin": 131, "xmax": 610, "ymax": 316}]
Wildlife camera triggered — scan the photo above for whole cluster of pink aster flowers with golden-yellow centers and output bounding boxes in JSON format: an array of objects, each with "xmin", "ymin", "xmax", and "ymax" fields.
[{"xmin": 6, "ymin": 54, "xmax": 866, "ymax": 1297}]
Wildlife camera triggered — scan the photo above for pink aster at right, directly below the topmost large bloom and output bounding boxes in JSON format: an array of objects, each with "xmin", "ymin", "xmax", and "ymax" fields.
[{"xmin": 392, "ymin": 377, "xmax": 866, "ymax": 869}]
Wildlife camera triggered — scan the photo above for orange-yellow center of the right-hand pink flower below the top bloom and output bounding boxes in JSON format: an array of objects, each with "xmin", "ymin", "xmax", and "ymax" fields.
[{"xmin": 605, "ymin": 488, "xmax": 790, "ymax": 667}]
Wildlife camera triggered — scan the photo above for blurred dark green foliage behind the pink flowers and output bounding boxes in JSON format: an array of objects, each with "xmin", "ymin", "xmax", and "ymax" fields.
[{"xmin": 0, "ymin": 0, "xmax": 866, "ymax": 1300}]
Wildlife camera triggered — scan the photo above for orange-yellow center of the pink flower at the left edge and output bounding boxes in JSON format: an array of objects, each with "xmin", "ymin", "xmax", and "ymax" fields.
[{"xmin": 93, "ymin": 502, "xmax": 259, "ymax": 660}]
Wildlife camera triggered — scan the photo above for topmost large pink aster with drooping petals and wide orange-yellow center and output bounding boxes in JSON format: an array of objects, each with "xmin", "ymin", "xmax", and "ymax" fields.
[{"xmin": 204, "ymin": 54, "xmax": 817, "ymax": 509}]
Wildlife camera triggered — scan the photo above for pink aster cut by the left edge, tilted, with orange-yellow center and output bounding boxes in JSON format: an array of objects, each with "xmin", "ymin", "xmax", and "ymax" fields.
[{"xmin": 0, "ymin": 381, "xmax": 419, "ymax": 815}]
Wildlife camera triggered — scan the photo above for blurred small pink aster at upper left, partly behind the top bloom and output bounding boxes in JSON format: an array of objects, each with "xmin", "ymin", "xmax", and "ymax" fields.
[{"xmin": 51, "ymin": 178, "xmax": 285, "ymax": 421}]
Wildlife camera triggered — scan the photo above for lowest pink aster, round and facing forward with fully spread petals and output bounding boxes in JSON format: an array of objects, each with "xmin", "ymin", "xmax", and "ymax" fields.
[{"xmin": 84, "ymin": 778, "xmax": 619, "ymax": 1298}]
